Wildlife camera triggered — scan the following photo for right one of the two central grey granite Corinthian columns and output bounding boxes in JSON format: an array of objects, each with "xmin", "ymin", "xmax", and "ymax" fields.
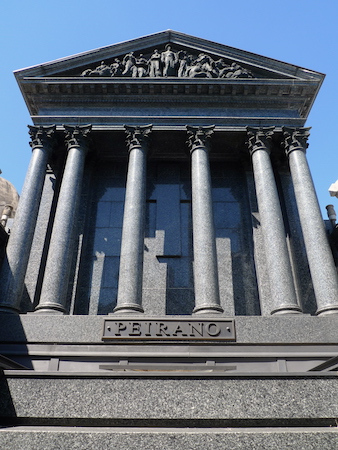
[{"xmin": 187, "ymin": 126, "xmax": 223, "ymax": 314}]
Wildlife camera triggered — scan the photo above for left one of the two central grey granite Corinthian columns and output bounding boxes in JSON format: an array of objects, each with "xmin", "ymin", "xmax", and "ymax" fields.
[{"xmin": 114, "ymin": 125, "xmax": 152, "ymax": 313}]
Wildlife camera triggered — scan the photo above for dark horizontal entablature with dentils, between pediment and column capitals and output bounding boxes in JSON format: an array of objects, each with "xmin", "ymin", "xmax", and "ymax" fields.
[{"xmin": 22, "ymin": 78, "xmax": 317, "ymax": 126}]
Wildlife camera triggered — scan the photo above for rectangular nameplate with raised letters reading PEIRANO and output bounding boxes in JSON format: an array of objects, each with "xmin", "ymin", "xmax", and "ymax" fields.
[{"xmin": 102, "ymin": 318, "xmax": 236, "ymax": 341}]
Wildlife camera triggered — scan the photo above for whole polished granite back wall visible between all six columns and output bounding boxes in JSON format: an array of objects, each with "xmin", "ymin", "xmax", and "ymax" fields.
[{"xmin": 22, "ymin": 158, "xmax": 315, "ymax": 316}]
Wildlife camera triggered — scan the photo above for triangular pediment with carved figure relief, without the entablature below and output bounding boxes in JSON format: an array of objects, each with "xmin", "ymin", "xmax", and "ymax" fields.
[{"xmin": 16, "ymin": 30, "xmax": 323, "ymax": 81}]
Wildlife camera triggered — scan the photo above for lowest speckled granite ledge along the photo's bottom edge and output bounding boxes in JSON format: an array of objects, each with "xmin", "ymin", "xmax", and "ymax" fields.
[{"xmin": 0, "ymin": 427, "xmax": 338, "ymax": 450}]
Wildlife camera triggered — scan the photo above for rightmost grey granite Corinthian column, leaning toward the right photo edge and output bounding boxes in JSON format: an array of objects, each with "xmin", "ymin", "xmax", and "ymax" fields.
[{"xmin": 283, "ymin": 128, "xmax": 338, "ymax": 315}]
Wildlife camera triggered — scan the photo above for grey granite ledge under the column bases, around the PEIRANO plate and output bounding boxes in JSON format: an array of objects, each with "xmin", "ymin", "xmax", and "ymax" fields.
[{"xmin": 0, "ymin": 314, "xmax": 338, "ymax": 345}]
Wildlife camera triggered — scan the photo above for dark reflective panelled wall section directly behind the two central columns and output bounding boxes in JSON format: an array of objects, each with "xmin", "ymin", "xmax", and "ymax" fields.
[{"xmin": 66, "ymin": 162, "xmax": 260, "ymax": 315}]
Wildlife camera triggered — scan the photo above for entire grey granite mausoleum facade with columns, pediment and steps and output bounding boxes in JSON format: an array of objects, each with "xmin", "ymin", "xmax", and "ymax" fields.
[{"xmin": 0, "ymin": 30, "xmax": 338, "ymax": 449}]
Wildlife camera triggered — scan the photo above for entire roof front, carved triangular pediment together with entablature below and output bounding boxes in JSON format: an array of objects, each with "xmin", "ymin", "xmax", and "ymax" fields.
[{"xmin": 15, "ymin": 30, "xmax": 324, "ymax": 128}]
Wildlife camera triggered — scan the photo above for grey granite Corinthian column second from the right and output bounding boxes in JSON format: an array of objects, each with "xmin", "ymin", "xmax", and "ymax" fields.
[{"xmin": 247, "ymin": 127, "xmax": 301, "ymax": 314}]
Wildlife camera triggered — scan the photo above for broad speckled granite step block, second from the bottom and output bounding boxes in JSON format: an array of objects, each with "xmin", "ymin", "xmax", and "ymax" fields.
[{"xmin": 0, "ymin": 371, "xmax": 338, "ymax": 420}]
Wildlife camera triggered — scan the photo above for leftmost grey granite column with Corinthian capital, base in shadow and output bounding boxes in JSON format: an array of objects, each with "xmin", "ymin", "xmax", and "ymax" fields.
[{"xmin": 0, "ymin": 125, "xmax": 55, "ymax": 312}]
